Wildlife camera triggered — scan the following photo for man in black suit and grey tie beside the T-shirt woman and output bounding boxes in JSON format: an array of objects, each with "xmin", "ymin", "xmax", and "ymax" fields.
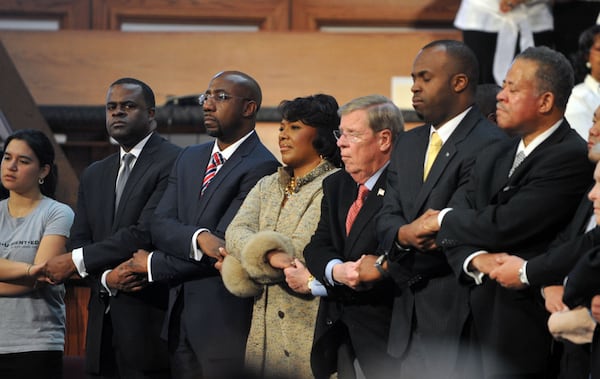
[{"xmin": 45, "ymin": 78, "xmax": 180, "ymax": 378}]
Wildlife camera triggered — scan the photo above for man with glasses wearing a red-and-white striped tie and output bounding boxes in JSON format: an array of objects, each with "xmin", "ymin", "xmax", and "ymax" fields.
[{"xmin": 131, "ymin": 71, "xmax": 279, "ymax": 379}]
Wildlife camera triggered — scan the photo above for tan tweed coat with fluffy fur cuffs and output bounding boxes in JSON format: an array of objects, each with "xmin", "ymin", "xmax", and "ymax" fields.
[{"xmin": 221, "ymin": 161, "xmax": 336, "ymax": 378}]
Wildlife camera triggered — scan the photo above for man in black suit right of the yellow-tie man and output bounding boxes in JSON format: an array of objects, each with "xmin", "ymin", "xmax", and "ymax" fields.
[{"xmin": 424, "ymin": 47, "xmax": 591, "ymax": 378}]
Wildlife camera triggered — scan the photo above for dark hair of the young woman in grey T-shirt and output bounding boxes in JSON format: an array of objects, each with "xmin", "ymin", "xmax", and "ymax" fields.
[{"xmin": 2, "ymin": 129, "xmax": 58, "ymax": 198}]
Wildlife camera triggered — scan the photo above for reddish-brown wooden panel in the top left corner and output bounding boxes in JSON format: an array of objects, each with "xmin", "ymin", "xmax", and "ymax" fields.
[{"xmin": 0, "ymin": 0, "xmax": 91, "ymax": 29}]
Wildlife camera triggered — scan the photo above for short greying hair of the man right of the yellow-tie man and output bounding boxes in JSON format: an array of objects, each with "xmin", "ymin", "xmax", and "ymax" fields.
[{"xmin": 515, "ymin": 46, "xmax": 575, "ymax": 111}]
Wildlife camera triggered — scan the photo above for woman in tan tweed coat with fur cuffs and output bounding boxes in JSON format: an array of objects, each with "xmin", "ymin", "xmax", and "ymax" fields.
[{"xmin": 221, "ymin": 95, "xmax": 340, "ymax": 378}]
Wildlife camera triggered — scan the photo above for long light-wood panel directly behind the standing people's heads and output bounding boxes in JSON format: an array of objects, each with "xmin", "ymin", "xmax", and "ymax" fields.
[{"xmin": 0, "ymin": 31, "xmax": 460, "ymax": 106}]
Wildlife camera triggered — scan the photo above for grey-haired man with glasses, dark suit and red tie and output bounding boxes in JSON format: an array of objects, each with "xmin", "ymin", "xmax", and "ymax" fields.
[{"xmin": 304, "ymin": 95, "xmax": 404, "ymax": 378}]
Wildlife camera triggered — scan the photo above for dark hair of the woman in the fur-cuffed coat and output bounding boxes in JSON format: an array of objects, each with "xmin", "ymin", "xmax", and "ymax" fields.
[{"xmin": 279, "ymin": 94, "xmax": 342, "ymax": 167}]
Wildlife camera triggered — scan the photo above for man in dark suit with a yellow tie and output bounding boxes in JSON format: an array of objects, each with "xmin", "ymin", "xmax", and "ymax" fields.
[{"xmin": 371, "ymin": 40, "xmax": 506, "ymax": 378}]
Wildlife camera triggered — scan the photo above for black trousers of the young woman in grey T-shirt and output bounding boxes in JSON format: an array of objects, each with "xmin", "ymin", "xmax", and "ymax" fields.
[{"xmin": 0, "ymin": 351, "xmax": 63, "ymax": 379}]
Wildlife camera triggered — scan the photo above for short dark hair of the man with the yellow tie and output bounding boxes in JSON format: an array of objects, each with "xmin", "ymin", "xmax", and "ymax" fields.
[{"xmin": 422, "ymin": 39, "xmax": 479, "ymax": 94}]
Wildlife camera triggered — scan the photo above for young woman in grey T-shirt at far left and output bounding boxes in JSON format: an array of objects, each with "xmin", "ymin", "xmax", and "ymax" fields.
[{"xmin": 0, "ymin": 129, "xmax": 73, "ymax": 379}]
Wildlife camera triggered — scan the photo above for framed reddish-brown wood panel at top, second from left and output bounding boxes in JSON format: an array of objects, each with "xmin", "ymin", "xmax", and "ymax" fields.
[{"xmin": 91, "ymin": 0, "xmax": 290, "ymax": 30}]
